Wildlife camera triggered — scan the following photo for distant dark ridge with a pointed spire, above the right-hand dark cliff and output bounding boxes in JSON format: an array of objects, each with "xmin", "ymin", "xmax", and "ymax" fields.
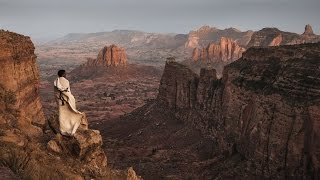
[{"xmin": 247, "ymin": 25, "xmax": 320, "ymax": 48}]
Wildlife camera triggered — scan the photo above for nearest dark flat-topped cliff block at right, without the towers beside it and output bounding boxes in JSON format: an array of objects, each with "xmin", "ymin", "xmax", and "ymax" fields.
[{"xmin": 221, "ymin": 44, "xmax": 320, "ymax": 179}]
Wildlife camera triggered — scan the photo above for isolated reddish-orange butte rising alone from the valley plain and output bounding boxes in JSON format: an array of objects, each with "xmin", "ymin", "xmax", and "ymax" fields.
[{"xmin": 86, "ymin": 44, "xmax": 128, "ymax": 67}]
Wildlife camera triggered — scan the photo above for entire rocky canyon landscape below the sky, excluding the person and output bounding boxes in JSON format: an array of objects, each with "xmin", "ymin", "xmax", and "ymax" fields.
[{"xmin": 0, "ymin": 25, "xmax": 320, "ymax": 179}]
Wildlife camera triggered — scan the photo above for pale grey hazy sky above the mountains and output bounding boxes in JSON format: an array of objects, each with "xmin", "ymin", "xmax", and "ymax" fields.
[{"xmin": 0, "ymin": 0, "xmax": 320, "ymax": 38}]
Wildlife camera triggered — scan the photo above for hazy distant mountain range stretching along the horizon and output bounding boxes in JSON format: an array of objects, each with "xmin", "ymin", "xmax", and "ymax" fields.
[{"xmin": 36, "ymin": 25, "xmax": 320, "ymax": 66}]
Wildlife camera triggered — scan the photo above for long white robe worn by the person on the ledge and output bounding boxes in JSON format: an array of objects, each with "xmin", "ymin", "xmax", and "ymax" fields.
[{"xmin": 54, "ymin": 77, "xmax": 85, "ymax": 135}]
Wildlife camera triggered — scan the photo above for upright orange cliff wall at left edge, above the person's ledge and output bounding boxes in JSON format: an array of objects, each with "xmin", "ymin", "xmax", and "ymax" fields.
[{"xmin": 0, "ymin": 30, "xmax": 45, "ymax": 136}]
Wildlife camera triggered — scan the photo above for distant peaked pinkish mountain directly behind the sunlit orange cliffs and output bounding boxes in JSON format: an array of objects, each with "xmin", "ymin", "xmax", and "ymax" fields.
[{"xmin": 185, "ymin": 26, "xmax": 253, "ymax": 49}]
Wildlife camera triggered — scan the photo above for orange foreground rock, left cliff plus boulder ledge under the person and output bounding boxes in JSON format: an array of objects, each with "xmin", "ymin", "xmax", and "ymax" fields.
[{"xmin": 0, "ymin": 30, "xmax": 139, "ymax": 179}]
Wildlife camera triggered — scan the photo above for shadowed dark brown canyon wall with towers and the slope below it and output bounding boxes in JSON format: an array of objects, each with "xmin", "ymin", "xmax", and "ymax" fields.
[{"xmin": 97, "ymin": 43, "xmax": 320, "ymax": 179}]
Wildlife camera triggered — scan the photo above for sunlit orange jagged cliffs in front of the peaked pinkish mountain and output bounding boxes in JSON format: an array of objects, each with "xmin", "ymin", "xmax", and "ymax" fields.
[{"xmin": 192, "ymin": 37, "xmax": 245, "ymax": 62}]
